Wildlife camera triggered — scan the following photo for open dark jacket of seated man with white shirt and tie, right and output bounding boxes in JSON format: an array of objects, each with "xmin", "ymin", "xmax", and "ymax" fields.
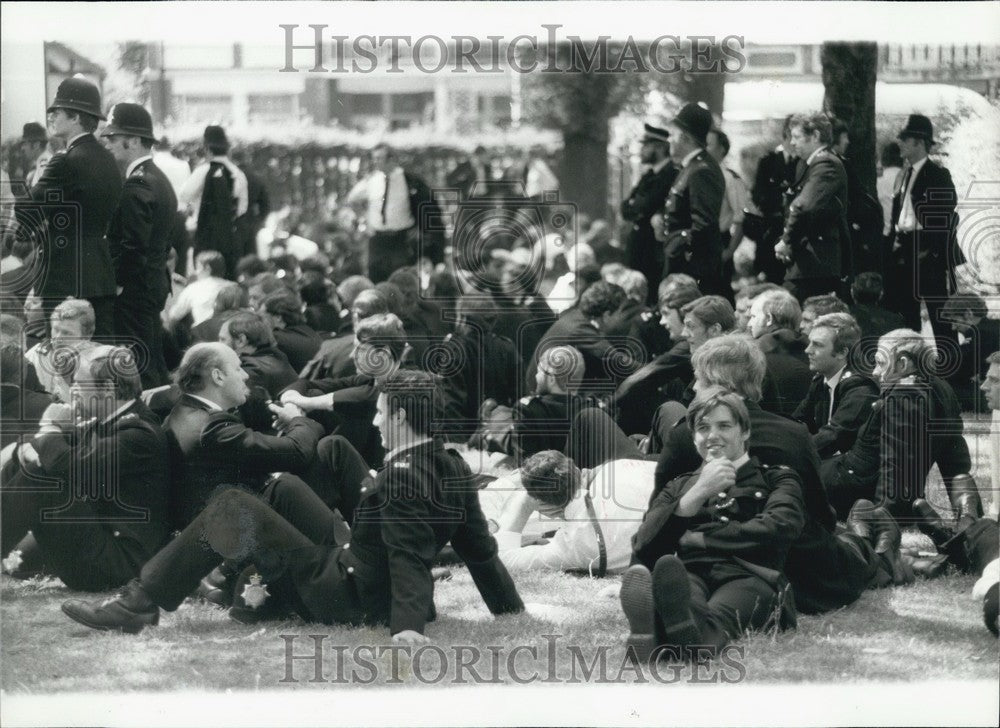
[{"xmin": 792, "ymin": 369, "xmax": 878, "ymax": 458}]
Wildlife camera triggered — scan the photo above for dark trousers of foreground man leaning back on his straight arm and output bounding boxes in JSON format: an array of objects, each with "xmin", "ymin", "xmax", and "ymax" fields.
[{"xmin": 140, "ymin": 488, "xmax": 342, "ymax": 611}]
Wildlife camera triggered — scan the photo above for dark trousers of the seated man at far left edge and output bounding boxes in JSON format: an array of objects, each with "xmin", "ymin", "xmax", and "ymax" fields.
[{"xmin": 0, "ymin": 464, "xmax": 146, "ymax": 591}]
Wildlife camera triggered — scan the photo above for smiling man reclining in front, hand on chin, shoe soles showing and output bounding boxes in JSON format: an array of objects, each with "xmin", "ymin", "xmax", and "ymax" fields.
[{"xmin": 621, "ymin": 387, "xmax": 806, "ymax": 662}]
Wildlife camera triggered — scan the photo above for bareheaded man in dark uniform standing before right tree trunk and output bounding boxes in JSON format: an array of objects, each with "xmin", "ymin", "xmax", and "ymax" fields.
[{"xmin": 774, "ymin": 113, "xmax": 851, "ymax": 303}]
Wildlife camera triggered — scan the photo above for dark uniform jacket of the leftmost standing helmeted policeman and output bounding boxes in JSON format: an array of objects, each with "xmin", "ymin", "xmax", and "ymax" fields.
[{"xmin": 23, "ymin": 134, "xmax": 122, "ymax": 298}]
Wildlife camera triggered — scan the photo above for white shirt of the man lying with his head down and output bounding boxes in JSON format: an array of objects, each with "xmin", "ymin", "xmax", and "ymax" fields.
[{"xmin": 495, "ymin": 460, "xmax": 656, "ymax": 572}]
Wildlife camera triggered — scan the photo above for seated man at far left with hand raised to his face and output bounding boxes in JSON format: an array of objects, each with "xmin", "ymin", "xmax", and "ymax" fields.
[{"xmin": 0, "ymin": 347, "xmax": 169, "ymax": 591}]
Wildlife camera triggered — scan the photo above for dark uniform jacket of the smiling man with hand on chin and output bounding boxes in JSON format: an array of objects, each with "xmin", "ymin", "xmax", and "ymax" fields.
[{"xmin": 632, "ymin": 458, "xmax": 806, "ymax": 572}]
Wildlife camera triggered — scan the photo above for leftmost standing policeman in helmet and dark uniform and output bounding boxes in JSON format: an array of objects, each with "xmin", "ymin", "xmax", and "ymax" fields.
[{"xmin": 15, "ymin": 78, "xmax": 122, "ymax": 339}]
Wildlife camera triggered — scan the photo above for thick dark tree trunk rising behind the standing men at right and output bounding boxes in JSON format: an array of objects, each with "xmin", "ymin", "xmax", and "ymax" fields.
[{"xmin": 820, "ymin": 43, "xmax": 878, "ymax": 195}]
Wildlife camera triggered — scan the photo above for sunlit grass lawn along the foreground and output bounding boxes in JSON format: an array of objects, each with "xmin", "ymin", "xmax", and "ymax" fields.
[{"xmin": 0, "ymin": 420, "xmax": 1000, "ymax": 697}]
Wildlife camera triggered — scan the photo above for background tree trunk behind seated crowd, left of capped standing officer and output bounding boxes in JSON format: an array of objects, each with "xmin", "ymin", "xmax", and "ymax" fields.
[{"xmin": 559, "ymin": 129, "xmax": 614, "ymax": 222}]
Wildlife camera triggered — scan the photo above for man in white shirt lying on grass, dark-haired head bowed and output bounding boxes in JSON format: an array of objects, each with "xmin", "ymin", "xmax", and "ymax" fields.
[{"xmin": 496, "ymin": 450, "xmax": 656, "ymax": 577}]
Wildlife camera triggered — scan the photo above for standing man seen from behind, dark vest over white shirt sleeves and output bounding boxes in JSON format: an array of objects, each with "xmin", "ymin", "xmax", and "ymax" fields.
[{"xmin": 177, "ymin": 126, "xmax": 250, "ymax": 280}]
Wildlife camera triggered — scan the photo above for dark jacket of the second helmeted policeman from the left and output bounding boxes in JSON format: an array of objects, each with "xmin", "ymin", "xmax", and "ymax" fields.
[{"xmin": 108, "ymin": 159, "xmax": 177, "ymax": 311}]
